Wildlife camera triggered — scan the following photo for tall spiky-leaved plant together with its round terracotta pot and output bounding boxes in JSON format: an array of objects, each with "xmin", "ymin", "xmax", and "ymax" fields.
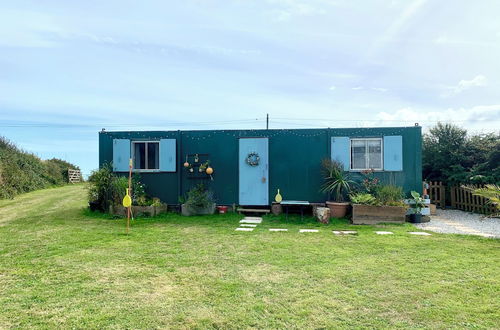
[{"xmin": 321, "ymin": 158, "xmax": 355, "ymax": 218}]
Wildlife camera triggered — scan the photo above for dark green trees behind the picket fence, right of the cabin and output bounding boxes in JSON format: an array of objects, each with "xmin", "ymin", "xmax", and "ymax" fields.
[{"xmin": 422, "ymin": 123, "xmax": 500, "ymax": 185}]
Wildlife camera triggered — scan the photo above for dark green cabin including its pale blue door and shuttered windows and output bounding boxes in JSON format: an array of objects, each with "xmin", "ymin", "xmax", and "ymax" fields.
[{"xmin": 99, "ymin": 126, "xmax": 422, "ymax": 205}]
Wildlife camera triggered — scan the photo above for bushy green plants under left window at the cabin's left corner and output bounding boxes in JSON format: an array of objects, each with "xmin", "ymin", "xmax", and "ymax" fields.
[{"xmin": 88, "ymin": 164, "xmax": 148, "ymax": 212}]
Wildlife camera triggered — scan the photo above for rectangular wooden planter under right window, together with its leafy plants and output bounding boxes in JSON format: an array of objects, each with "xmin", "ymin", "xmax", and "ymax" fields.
[{"xmin": 350, "ymin": 185, "xmax": 406, "ymax": 225}]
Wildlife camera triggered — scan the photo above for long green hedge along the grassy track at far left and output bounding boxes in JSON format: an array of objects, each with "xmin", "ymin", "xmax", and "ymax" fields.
[{"xmin": 0, "ymin": 137, "xmax": 78, "ymax": 199}]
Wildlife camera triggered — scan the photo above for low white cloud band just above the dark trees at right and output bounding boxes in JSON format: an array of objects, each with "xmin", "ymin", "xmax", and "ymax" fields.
[{"xmin": 376, "ymin": 104, "xmax": 500, "ymax": 130}]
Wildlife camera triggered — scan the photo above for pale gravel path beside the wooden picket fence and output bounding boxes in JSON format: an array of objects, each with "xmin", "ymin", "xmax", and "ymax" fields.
[{"xmin": 415, "ymin": 209, "xmax": 500, "ymax": 238}]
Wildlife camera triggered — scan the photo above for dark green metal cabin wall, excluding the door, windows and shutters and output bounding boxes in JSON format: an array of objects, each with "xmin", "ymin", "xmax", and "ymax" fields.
[{"xmin": 99, "ymin": 127, "xmax": 422, "ymax": 204}]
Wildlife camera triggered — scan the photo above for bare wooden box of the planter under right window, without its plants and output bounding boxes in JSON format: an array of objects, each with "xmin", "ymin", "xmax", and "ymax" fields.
[{"xmin": 352, "ymin": 204, "xmax": 406, "ymax": 225}]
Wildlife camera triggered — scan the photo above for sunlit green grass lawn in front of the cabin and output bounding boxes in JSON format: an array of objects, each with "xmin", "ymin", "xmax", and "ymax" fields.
[{"xmin": 0, "ymin": 185, "xmax": 500, "ymax": 329}]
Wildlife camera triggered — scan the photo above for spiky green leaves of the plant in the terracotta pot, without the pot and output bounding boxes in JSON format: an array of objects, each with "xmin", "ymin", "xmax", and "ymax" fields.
[{"xmin": 320, "ymin": 158, "xmax": 355, "ymax": 202}]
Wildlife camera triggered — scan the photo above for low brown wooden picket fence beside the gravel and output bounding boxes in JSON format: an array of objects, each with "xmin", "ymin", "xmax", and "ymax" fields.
[{"xmin": 427, "ymin": 181, "xmax": 496, "ymax": 214}]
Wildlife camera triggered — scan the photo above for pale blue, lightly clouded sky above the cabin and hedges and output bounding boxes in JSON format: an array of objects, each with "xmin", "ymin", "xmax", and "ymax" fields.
[{"xmin": 0, "ymin": 0, "xmax": 500, "ymax": 174}]
